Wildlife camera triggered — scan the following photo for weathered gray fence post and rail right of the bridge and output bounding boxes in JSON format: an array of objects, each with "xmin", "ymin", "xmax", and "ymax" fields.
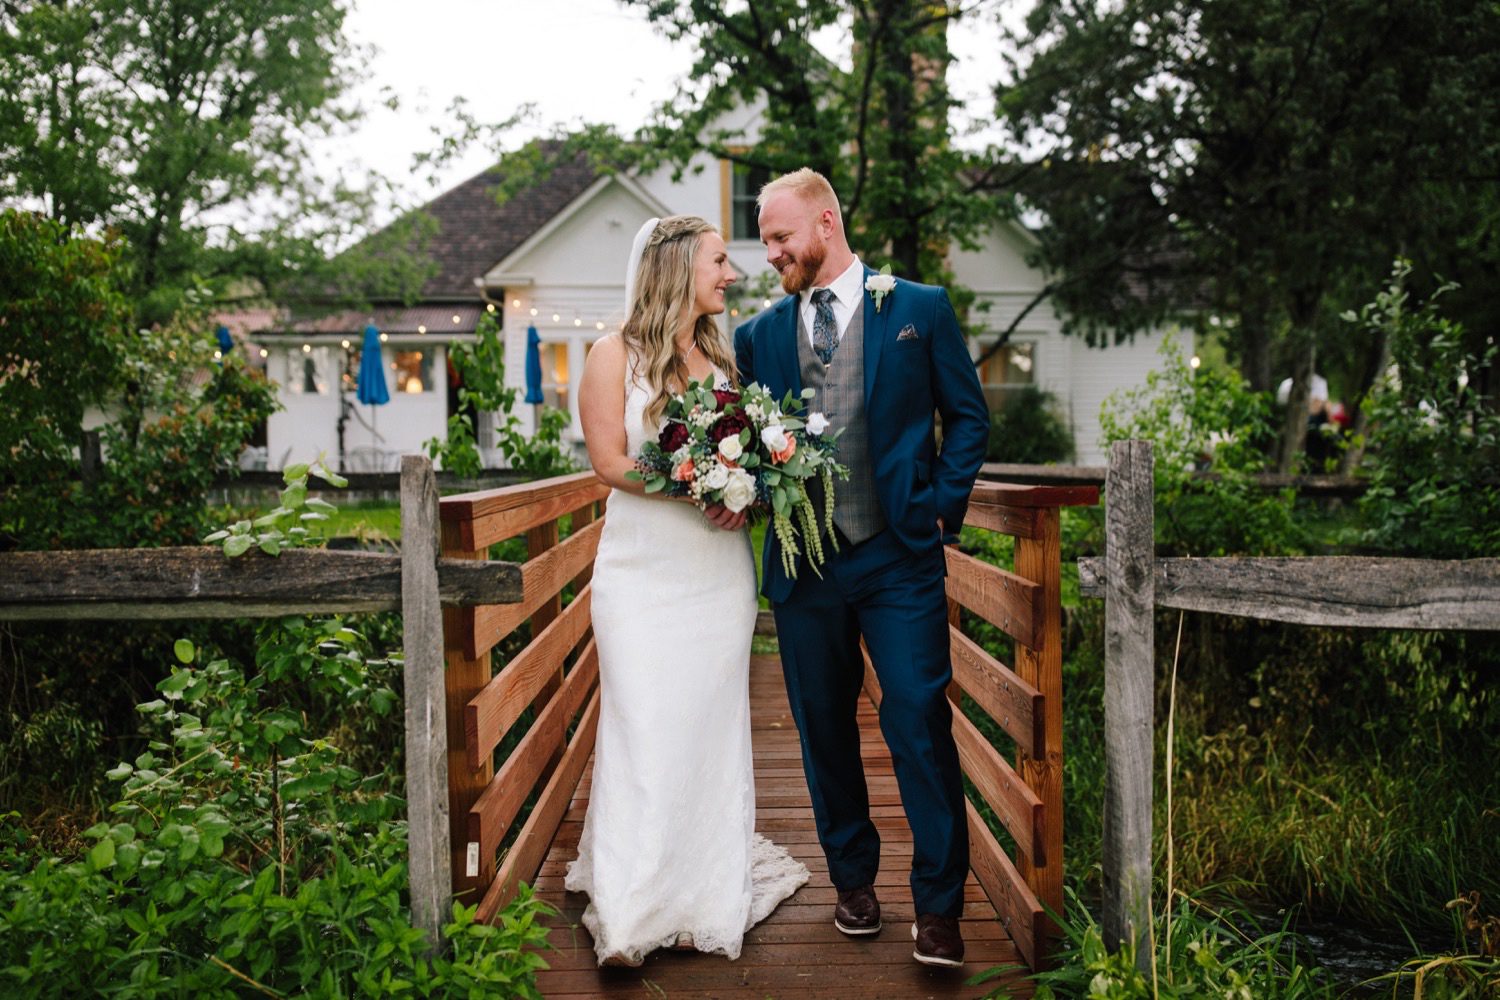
[{"xmin": 1079, "ymin": 441, "xmax": 1500, "ymax": 967}]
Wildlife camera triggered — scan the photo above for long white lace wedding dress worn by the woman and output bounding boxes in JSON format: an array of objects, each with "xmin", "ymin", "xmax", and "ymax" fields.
[{"xmin": 567, "ymin": 364, "xmax": 807, "ymax": 964}]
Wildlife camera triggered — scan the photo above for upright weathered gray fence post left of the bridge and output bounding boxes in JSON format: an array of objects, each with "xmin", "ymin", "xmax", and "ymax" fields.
[{"xmin": 401, "ymin": 454, "xmax": 453, "ymax": 949}]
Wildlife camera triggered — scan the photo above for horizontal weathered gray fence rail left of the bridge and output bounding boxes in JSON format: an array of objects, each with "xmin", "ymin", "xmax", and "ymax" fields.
[{"xmin": 0, "ymin": 546, "xmax": 522, "ymax": 621}]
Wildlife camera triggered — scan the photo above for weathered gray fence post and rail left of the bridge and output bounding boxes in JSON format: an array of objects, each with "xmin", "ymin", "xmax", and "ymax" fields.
[{"xmin": 0, "ymin": 456, "xmax": 524, "ymax": 945}]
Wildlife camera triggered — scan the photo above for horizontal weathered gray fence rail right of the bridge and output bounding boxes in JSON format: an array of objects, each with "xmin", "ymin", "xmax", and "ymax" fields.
[{"xmin": 1079, "ymin": 556, "xmax": 1500, "ymax": 631}]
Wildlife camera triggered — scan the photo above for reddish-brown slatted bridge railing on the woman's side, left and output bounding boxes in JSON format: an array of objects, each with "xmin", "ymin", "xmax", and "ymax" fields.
[{"xmin": 440, "ymin": 472, "xmax": 609, "ymax": 921}]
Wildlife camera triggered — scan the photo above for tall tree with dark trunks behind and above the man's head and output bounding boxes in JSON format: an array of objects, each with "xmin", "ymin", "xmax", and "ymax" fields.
[{"xmin": 561, "ymin": 0, "xmax": 996, "ymax": 289}]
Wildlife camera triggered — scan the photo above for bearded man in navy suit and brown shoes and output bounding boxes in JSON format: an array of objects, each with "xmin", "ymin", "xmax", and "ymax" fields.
[{"xmin": 735, "ymin": 168, "xmax": 990, "ymax": 966}]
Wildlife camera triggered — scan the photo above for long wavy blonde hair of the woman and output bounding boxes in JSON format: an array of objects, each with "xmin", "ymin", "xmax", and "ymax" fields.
[{"xmin": 620, "ymin": 216, "xmax": 740, "ymax": 427}]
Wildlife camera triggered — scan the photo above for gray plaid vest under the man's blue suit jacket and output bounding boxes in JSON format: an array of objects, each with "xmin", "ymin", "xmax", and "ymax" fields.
[{"xmin": 797, "ymin": 300, "xmax": 885, "ymax": 544}]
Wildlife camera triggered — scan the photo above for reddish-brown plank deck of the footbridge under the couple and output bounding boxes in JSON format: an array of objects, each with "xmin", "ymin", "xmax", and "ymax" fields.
[{"xmin": 536, "ymin": 657, "xmax": 1032, "ymax": 1000}]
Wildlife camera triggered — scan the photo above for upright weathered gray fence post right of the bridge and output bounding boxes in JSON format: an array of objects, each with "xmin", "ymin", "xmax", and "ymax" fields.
[{"xmin": 1104, "ymin": 441, "xmax": 1157, "ymax": 972}]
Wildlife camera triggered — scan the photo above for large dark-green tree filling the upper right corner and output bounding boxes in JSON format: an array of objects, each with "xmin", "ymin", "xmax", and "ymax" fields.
[{"xmin": 999, "ymin": 0, "xmax": 1500, "ymax": 468}]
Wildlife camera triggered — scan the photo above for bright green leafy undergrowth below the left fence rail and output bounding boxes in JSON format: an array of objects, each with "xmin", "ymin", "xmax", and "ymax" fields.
[{"xmin": 0, "ymin": 629, "xmax": 545, "ymax": 997}]
